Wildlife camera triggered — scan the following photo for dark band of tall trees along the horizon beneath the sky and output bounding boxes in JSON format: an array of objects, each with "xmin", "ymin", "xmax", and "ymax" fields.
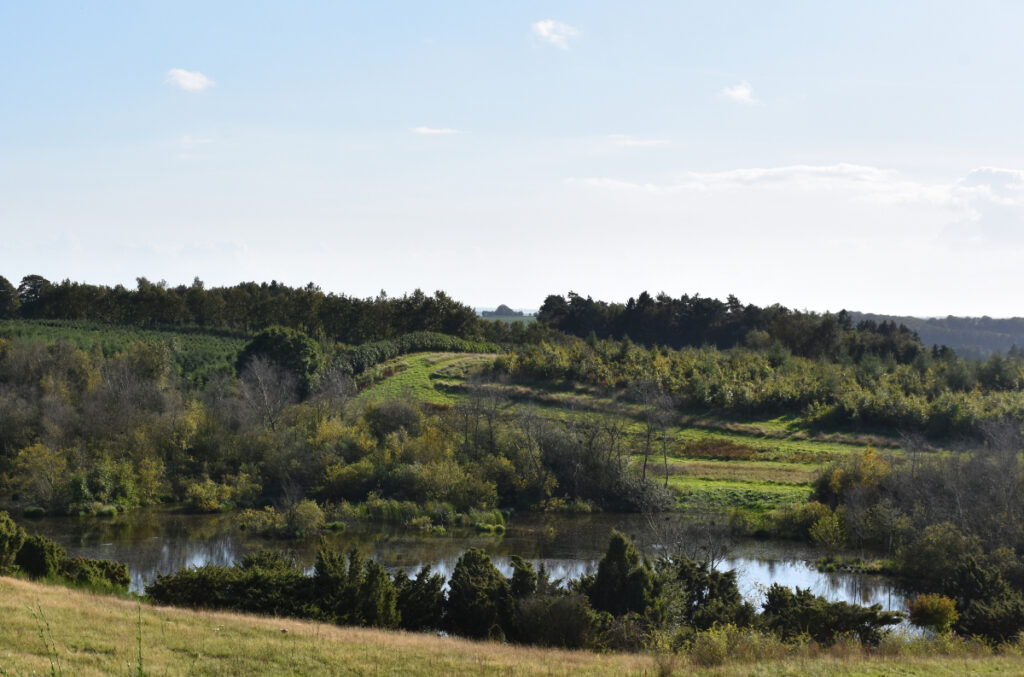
[{"xmin": 0, "ymin": 274, "xmax": 937, "ymax": 364}]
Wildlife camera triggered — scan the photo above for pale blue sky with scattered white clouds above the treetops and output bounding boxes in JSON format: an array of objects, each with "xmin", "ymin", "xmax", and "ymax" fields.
[{"xmin": 0, "ymin": 0, "xmax": 1024, "ymax": 316}]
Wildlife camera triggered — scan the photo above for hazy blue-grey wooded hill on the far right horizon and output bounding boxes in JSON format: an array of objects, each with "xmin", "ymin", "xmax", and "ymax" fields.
[{"xmin": 850, "ymin": 312, "xmax": 1024, "ymax": 357}]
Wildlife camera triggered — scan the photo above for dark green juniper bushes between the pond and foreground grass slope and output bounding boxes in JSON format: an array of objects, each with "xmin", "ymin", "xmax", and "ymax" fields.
[{"xmin": 146, "ymin": 533, "xmax": 901, "ymax": 660}]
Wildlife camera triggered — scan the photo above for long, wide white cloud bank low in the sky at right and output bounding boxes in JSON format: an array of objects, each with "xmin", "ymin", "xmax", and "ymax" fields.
[{"xmin": 567, "ymin": 163, "xmax": 1024, "ymax": 250}]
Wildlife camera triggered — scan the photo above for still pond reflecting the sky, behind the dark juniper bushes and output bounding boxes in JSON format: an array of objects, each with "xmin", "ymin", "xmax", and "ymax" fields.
[{"xmin": 20, "ymin": 511, "xmax": 906, "ymax": 610}]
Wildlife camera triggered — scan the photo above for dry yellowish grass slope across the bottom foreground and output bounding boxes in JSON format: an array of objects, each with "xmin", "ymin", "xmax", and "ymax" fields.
[{"xmin": 0, "ymin": 578, "xmax": 1024, "ymax": 677}]
